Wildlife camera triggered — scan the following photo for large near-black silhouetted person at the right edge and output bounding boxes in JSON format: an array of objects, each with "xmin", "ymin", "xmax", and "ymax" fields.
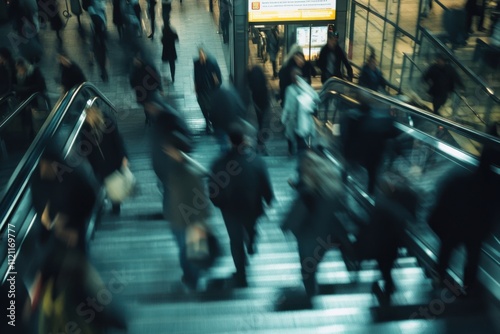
[{"xmin": 427, "ymin": 132, "xmax": 500, "ymax": 295}]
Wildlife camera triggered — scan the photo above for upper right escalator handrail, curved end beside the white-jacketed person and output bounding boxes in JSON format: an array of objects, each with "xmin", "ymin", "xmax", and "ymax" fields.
[{"xmin": 320, "ymin": 77, "xmax": 500, "ymax": 150}]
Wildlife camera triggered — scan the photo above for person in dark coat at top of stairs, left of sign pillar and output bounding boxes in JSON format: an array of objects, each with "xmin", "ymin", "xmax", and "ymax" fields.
[{"xmin": 194, "ymin": 47, "xmax": 222, "ymax": 133}]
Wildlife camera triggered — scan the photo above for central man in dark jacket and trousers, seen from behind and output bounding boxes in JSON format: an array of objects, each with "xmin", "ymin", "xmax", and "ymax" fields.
[{"xmin": 209, "ymin": 127, "xmax": 274, "ymax": 287}]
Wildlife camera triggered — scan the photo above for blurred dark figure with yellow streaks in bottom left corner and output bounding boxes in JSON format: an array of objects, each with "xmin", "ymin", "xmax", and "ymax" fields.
[{"xmin": 33, "ymin": 228, "xmax": 130, "ymax": 334}]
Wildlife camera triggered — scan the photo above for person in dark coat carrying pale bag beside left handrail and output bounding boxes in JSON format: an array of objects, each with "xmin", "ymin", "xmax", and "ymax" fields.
[{"xmin": 82, "ymin": 106, "xmax": 128, "ymax": 214}]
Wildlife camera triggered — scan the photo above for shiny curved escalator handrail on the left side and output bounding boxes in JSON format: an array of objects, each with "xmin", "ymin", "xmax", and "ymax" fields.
[{"xmin": 0, "ymin": 82, "xmax": 116, "ymax": 235}]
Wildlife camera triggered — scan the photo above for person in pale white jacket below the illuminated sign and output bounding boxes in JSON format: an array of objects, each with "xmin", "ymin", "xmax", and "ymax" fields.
[{"xmin": 281, "ymin": 68, "xmax": 319, "ymax": 155}]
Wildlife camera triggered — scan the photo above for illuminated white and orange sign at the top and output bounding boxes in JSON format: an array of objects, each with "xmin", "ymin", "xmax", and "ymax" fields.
[{"xmin": 248, "ymin": 0, "xmax": 336, "ymax": 22}]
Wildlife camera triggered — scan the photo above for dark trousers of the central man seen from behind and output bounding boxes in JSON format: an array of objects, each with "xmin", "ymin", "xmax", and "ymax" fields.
[{"xmin": 222, "ymin": 211, "xmax": 257, "ymax": 279}]
